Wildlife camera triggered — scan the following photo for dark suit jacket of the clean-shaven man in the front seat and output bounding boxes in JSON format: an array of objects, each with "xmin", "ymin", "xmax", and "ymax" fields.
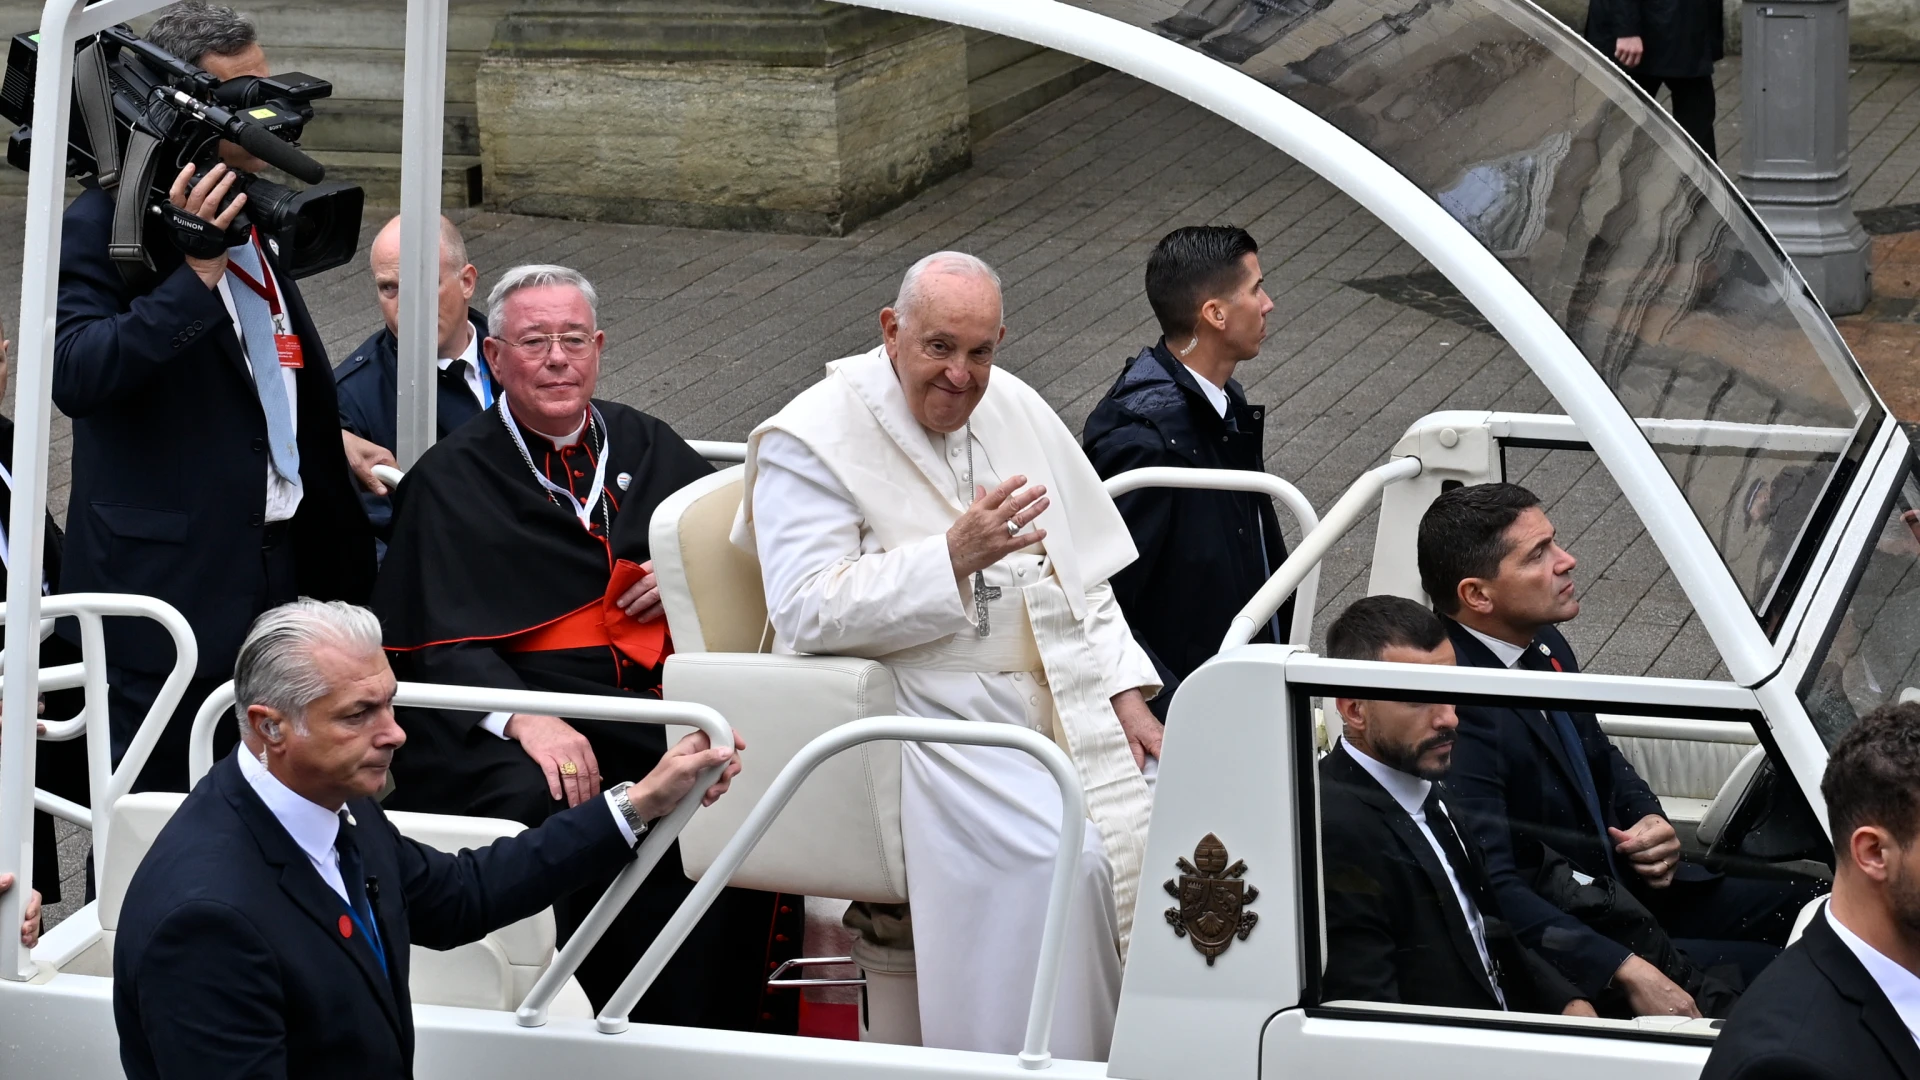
[{"xmin": 1446, "ymin": 619, "xmax": 1707, "ymax": 995}]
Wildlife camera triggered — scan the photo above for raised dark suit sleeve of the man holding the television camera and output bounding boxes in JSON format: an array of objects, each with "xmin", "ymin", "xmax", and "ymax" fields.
[{"xmin": 54, "ymin": 192, "xmax": 232, "ymax": 419}]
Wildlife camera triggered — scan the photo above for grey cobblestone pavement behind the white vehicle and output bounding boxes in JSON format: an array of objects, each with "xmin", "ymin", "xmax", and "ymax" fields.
[{"xmin": 15, "ymin": 63, "xmax": 1920, "ymax": 914}]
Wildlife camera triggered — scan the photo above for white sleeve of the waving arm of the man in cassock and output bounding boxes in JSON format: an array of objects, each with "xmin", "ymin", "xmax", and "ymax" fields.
[{"xmin": 753, "ymin": 430, "xmax": 972, "ymax": 655}]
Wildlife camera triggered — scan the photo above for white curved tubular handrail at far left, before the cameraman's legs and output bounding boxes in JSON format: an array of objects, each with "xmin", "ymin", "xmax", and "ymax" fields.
[{"xmin": 0, "ymin": 592, "xmax": 200, "ymax": 886}]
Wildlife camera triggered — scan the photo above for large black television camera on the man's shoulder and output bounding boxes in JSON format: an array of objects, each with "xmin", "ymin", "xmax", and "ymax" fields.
[{"xmin": 0, "ymin": 25, "xmax": 365, "ymax": 281}]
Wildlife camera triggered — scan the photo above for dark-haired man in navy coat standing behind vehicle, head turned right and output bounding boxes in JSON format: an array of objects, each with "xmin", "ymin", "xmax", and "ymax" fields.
[{"xmin": 1081, "ymin": 225, "xmax": 1292, "ymax": 721}]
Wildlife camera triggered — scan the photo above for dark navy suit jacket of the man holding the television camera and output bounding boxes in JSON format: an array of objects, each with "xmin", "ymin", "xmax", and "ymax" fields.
[{"xmin": 54, "ymin": 188, "xmax": 374, "ymax": 676}]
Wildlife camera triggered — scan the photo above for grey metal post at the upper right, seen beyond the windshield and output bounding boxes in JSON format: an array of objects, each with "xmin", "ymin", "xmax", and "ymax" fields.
[{"xmin": 1740, "ymin": 0, "xmax": 1870, "ymax": 315}]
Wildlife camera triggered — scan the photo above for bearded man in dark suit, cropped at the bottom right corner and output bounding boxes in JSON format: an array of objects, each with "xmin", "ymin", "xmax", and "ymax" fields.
[{"xmin": 1701, "ymin": 705, "xmax": 1920, "ymax": 1080}]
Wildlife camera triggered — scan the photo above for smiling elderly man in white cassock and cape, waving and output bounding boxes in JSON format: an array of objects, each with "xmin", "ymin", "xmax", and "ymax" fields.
[{"xmin": 733, "ymin": 252, "xmax": 1162, "ymax": 1061}]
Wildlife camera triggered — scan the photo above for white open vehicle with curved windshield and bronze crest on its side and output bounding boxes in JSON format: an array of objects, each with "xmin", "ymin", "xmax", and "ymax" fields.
[{"xmin": 0, "ymin": 0, "xmax": 1920, "ymax": 1080}]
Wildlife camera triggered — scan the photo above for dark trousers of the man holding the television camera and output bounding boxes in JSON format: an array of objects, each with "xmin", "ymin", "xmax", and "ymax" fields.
[{"xmin": 108, "ymin": 521, "xmax": 300, "ymax": 792}]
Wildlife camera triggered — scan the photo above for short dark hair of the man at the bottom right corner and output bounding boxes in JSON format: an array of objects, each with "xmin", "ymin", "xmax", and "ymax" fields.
[{"xmin": 1820, "ymin": 703, "xmax": 1920, "ymax": 859}]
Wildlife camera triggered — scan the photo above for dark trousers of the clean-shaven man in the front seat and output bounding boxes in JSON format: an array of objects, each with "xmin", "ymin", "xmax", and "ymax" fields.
[{"xmin": 1638, "ymin": 874, "xmax": 1826, "ymax": 986}]
